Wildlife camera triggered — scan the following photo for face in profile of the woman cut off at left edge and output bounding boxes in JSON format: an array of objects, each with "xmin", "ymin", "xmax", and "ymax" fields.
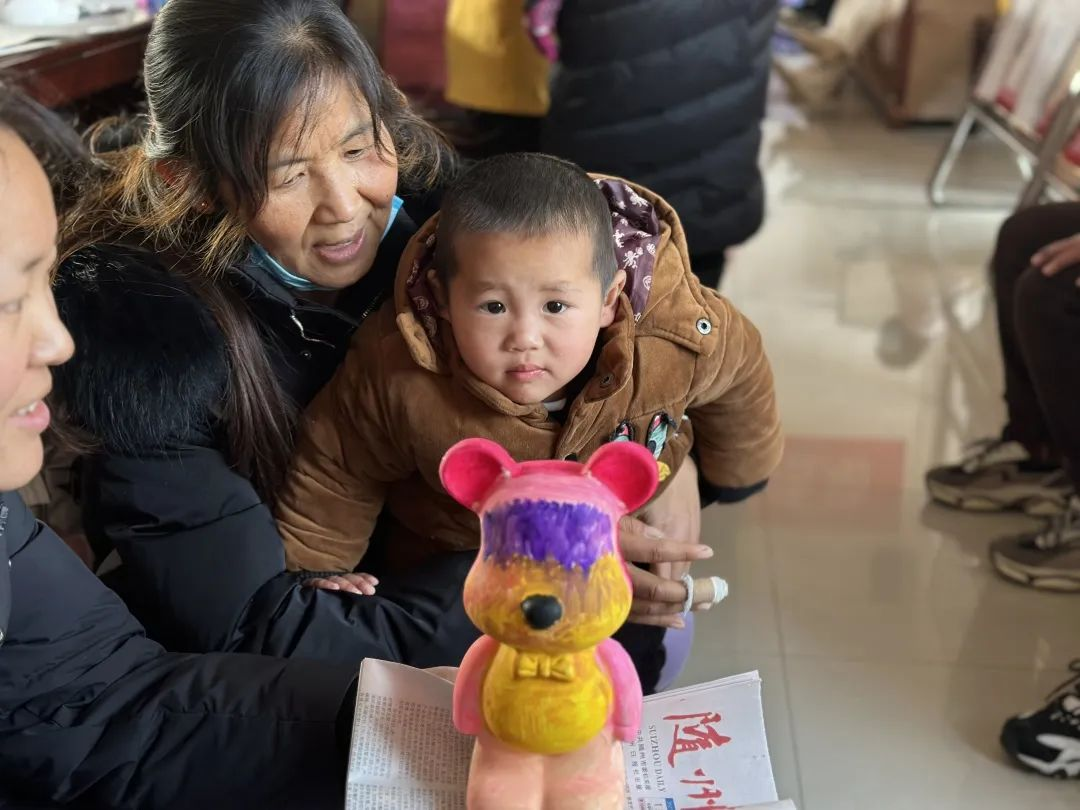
[{"xmin": 0, "ymin": 129, "xmax": 73, "ymax": 490}]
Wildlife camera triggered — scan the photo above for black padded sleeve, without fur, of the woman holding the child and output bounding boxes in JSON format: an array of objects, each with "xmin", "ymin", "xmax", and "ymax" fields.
[{"xmin": 84, "ymin": 448, "xmax": 478, "ymax": 666}]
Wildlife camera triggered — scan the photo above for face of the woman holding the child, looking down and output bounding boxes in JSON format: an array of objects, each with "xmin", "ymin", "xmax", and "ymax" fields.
[{"xmin": 240, "ymin": 80, "xmax": 397, "ymax": 289}]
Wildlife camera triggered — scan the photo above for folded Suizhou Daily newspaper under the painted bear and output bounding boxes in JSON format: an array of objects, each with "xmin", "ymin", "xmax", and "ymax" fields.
[{"xmin": 346, "ymin": 659, "xmax": 795, "ymax": 810}]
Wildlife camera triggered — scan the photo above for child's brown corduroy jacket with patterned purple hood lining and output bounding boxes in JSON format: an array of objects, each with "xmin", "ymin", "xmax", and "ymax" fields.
[{"xmin": 278, "ymin": 179, "xmax": 783, "ymax": 571}]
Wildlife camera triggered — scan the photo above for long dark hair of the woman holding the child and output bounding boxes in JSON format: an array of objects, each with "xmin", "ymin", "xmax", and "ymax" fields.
[{"xmin": 60, "ymin": 0, "xmax": 450, "ymax": 501}]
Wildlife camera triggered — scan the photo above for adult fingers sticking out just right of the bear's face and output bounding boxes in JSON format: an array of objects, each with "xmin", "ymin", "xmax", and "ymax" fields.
[{"xmin": 619, "ymin": 517, "xmax": 713, "ymax": 627}]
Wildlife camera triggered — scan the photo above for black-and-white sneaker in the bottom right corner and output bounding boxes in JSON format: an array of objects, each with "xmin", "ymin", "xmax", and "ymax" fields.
[{"xmin": 1001, "ymin": 659, "xmax": 1080, "ymax": 779}]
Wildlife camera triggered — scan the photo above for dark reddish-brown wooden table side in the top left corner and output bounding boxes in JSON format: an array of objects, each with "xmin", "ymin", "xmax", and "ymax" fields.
[{"xmin": 0, "ymin": 19, "xmax": 150, "ymax": 107}]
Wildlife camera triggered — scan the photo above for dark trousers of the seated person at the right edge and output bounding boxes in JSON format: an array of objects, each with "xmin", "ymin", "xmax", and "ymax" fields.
[{"xmin": 991, "ymin": 203, "xmax": 1080, "ymax": 489}]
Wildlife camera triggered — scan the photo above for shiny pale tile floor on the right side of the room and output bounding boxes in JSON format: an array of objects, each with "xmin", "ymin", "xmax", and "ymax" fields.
[{"xmin": 683, "ymin": 84, "xmax": 1080, "ymax": 810}]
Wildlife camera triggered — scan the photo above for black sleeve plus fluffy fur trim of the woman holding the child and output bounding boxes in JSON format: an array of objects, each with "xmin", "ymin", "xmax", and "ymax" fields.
[{"xmin": 54, "ymin": 248, "xmax": 476, "ymax": 666}]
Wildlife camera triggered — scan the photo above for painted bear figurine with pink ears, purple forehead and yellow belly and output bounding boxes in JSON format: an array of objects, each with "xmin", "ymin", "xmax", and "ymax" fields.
[{"xmin": 440, "ymin": 438, "xmax": 657, "ymax": 810}]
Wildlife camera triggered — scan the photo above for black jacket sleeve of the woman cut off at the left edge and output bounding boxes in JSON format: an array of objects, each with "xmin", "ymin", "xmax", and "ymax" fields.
[{"xmin": 0, "ymin": 496, "xmax": 355, "ymax": 810}]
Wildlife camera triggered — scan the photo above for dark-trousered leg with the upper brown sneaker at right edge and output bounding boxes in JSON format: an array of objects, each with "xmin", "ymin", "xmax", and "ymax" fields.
[{"xmin": 927, "ymin": 203, "xmax": 1080, "ymax": 515}]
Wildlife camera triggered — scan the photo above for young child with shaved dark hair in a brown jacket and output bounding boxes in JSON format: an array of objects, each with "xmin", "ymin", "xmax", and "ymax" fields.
[{"xmin": 278, "ymin": 153, "xmax": 782, "ymax": 592}]
